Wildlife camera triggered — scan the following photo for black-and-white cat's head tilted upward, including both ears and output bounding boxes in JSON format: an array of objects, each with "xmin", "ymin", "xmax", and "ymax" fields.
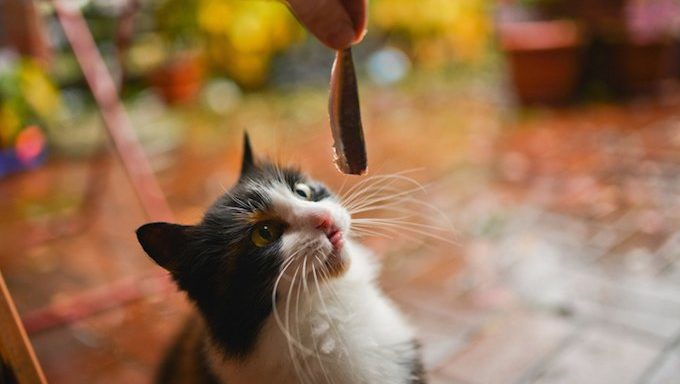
[{"xmin": 137, "ymin": 135, "xmax": 350, "ymax": 312}]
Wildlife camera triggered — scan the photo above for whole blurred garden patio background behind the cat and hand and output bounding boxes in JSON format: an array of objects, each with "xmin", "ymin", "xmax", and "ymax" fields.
[{"xmin": 0, "ymin": 0, "xmax": 680, "ymax": 384}]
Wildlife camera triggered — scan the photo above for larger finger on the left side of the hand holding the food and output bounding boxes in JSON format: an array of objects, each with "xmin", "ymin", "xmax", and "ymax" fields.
[{"xmin": 288, "ymin": 0, "xmax": 356, "ymax": 49}]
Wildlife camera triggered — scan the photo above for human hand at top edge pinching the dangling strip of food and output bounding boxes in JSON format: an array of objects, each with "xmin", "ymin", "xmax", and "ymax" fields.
[{"xmin": 284, "ymin": 0, "xmax": 366, "ymax": 49}]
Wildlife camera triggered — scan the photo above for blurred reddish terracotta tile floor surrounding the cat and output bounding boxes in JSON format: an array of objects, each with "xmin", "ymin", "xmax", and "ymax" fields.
[{"xmin": 0, "ymin": 87, "xmax": 680, "ymax": 384}]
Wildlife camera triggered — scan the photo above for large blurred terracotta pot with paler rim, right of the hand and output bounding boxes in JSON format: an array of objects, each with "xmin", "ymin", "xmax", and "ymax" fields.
[{"xmin": 498, "ymin": 20, "xmax": 583, "ymax": 104}]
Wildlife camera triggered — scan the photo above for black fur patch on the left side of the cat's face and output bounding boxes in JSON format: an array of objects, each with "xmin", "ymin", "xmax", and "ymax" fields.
[{"xmin": 175, "ymin": 167, "xmax": 301, "ymax": 358}]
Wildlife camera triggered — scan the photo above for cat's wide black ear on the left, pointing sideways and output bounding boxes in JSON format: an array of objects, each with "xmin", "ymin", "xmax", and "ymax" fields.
[{"xmin": 137, "ymin": 223, "xmax": 192, "ymax": 273}]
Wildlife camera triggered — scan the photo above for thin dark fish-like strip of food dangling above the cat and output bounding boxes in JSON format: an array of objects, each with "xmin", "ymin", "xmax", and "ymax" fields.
[{"xmin": 328, "ymin": 48, "xmax": 367, "ymax": 175}]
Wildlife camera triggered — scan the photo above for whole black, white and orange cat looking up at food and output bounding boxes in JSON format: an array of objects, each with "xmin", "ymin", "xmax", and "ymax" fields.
[{"xmin": 137, "ymin": 134, "xmax": 425, "ymax": 384}]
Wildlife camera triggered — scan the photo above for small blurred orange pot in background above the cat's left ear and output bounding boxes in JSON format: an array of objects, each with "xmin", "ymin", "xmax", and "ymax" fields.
[{"xmin": 151, "ymin": 54, "xmax": 203, "ymax": 104}]
